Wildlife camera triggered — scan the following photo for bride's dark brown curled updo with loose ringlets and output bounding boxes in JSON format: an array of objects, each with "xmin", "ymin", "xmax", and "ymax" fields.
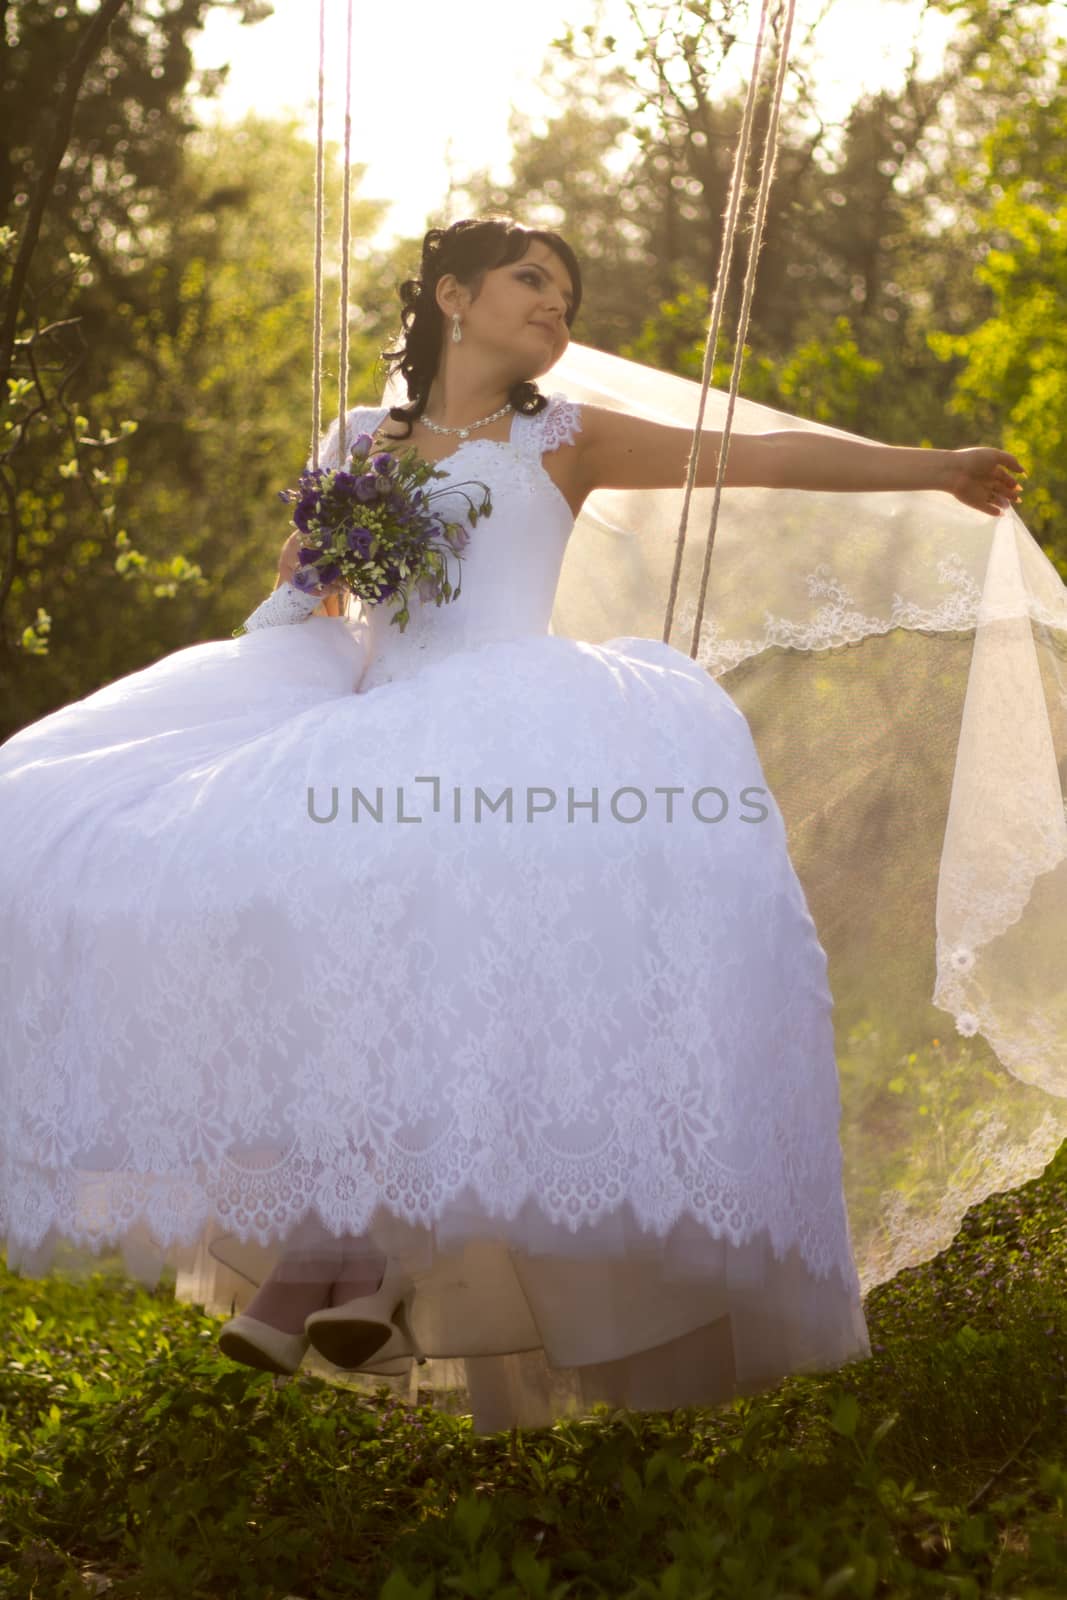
[{"xmin": 382, "ymin": 216, "xmax": 582, "ymax": 438}]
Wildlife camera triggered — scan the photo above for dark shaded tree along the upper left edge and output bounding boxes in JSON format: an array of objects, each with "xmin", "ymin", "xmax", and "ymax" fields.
[{"xmin": 0, "ymin": 0, "xmax": 266, "ymax": 726}]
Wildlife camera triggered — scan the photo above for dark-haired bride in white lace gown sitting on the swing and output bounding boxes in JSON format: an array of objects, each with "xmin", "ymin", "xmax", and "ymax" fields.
[{"xmin": 0, "ymin": 216, "xmax": 1022, "ymax": 1432}]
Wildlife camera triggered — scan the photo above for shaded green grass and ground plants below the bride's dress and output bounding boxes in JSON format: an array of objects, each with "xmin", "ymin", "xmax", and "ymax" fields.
[{"xmin": 0, "ymin": 1146, "xmax": 1067, "ymax": 1600}]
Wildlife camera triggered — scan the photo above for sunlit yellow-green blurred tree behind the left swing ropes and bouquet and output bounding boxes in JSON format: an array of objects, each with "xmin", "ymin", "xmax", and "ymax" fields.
[{"xmin": 90, "ymin": 115, "xmax": 388, "ymax": 636}]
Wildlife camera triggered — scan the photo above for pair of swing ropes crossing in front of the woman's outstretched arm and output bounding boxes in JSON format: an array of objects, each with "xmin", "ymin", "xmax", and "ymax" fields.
[{"xmin": 662, "ymin": 0, "xmax": 797, "ymax": 659}]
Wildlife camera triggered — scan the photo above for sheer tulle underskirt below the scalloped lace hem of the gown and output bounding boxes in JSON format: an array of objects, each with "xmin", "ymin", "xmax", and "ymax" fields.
[{"xmin": 8, "ymin": 1197, "xmax": 870, "ymax": 1434}]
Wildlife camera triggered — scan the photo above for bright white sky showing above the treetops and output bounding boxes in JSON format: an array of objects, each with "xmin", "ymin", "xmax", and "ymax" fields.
[{"xmin": 194, "ymin": 0, "xmax": 955, "ymax": 243}]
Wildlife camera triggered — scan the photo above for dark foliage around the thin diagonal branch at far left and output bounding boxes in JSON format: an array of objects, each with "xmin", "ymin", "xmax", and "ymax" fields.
[{"xmin": 0, "ymin": 0, "xmax": 269, "ymax": 700}]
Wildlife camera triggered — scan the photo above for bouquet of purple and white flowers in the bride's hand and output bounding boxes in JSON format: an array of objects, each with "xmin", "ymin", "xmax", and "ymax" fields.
[{"xmin": 234, "ymin": 434, "xmax": 493, "ymax": 637}]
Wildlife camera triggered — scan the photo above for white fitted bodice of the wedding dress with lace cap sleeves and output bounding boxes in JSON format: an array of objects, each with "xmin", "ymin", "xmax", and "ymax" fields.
[{"xmin": 318, "ymin": 395, "xmax": 581, "ymax": 693}]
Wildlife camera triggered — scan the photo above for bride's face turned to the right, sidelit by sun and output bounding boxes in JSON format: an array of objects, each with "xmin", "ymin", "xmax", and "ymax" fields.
[{"xmin": 461, "ymin": 238, "xmax": 574, "ymax": 378}]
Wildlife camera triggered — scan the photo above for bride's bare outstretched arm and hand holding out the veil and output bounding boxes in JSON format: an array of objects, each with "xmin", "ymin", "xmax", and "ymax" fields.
[{"xmin": 576, "ymin": 405, "xmax": 1025, "ymax": 515}]
